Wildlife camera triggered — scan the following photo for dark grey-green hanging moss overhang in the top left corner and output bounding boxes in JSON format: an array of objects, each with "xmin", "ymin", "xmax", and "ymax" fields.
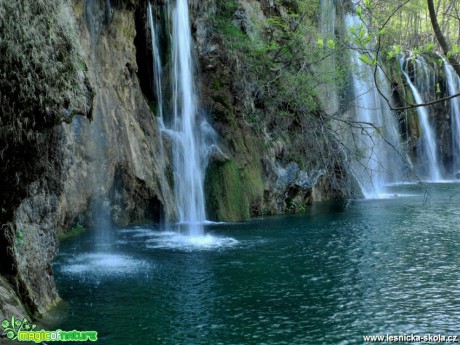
[{"xmin": 0, "ymin": 0, "xmax": 90, "ymax": 141}]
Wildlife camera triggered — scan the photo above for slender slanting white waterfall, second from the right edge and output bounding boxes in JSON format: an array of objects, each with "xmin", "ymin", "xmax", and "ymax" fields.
[{"xmin": 400, "ymin": 57, "xmax": 442, "ymax": 181}]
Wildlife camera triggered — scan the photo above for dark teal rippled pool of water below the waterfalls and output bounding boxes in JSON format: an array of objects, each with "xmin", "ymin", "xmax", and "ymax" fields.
[{"xmin": 54, "ymin": 184, "xmax": 460, "ymax": 345}]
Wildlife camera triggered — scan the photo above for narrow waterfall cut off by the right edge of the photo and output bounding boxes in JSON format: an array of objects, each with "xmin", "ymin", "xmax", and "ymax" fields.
[{"xmin": 444, "ymin": 60, "xmax": 460, "ymax": 179}]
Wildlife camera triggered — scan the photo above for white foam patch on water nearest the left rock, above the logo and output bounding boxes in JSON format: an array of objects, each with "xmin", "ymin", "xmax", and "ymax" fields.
[{"xmin": 61, "ymin": 253, "xmax": 150, "ymax": 275}]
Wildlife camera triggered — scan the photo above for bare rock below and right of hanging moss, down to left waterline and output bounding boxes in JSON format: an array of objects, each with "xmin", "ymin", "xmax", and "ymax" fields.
[{"xmin": 0, "ymin": 0, "xmax": 175, "ymax": 315}]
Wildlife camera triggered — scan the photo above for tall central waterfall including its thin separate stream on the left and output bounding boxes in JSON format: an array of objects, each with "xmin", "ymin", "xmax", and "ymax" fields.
[{"xmin": 147, "ymin": 0, "xmax": 215, "ymax": 236}]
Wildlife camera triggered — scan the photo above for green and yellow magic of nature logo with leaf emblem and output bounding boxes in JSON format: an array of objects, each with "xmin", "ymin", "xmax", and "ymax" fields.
[{"xmin": 0, "ymin": 316, "xmax": 97, "ymax": 344}]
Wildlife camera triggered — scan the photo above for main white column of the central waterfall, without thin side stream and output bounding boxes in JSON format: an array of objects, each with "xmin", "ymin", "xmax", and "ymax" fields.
[{"xmin": 172, "ymin": 0, "xmax": 206, "ymax": 236}]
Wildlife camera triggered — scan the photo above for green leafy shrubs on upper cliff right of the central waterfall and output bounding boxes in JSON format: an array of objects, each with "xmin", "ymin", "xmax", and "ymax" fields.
[{"xmin": 214, "ymin": 0, "xmax": 338, "ymax": 121}]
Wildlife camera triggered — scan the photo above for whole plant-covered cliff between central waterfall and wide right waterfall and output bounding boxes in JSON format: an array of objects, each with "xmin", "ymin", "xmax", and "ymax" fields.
[{"xmin": 202, "ymin": 1, "xmax": 353, "ymax": 219}]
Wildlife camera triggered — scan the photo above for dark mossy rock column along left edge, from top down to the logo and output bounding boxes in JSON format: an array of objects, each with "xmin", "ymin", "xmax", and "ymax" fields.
[{"xmin": 0, "ymin": 1, "xmax": 92, "ymax": 315}]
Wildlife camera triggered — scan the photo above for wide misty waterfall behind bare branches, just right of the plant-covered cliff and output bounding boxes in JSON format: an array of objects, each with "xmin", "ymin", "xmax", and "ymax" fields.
[{"xmin": 345, "ymin": 14, "xmax": 403, "ymax": 198}]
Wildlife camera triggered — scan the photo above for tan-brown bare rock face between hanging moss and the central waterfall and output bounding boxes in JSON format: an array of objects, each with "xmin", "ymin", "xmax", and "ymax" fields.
[{"xmin": 60, "ymin": 1, "xmax": 175, "ymax": 225}]
